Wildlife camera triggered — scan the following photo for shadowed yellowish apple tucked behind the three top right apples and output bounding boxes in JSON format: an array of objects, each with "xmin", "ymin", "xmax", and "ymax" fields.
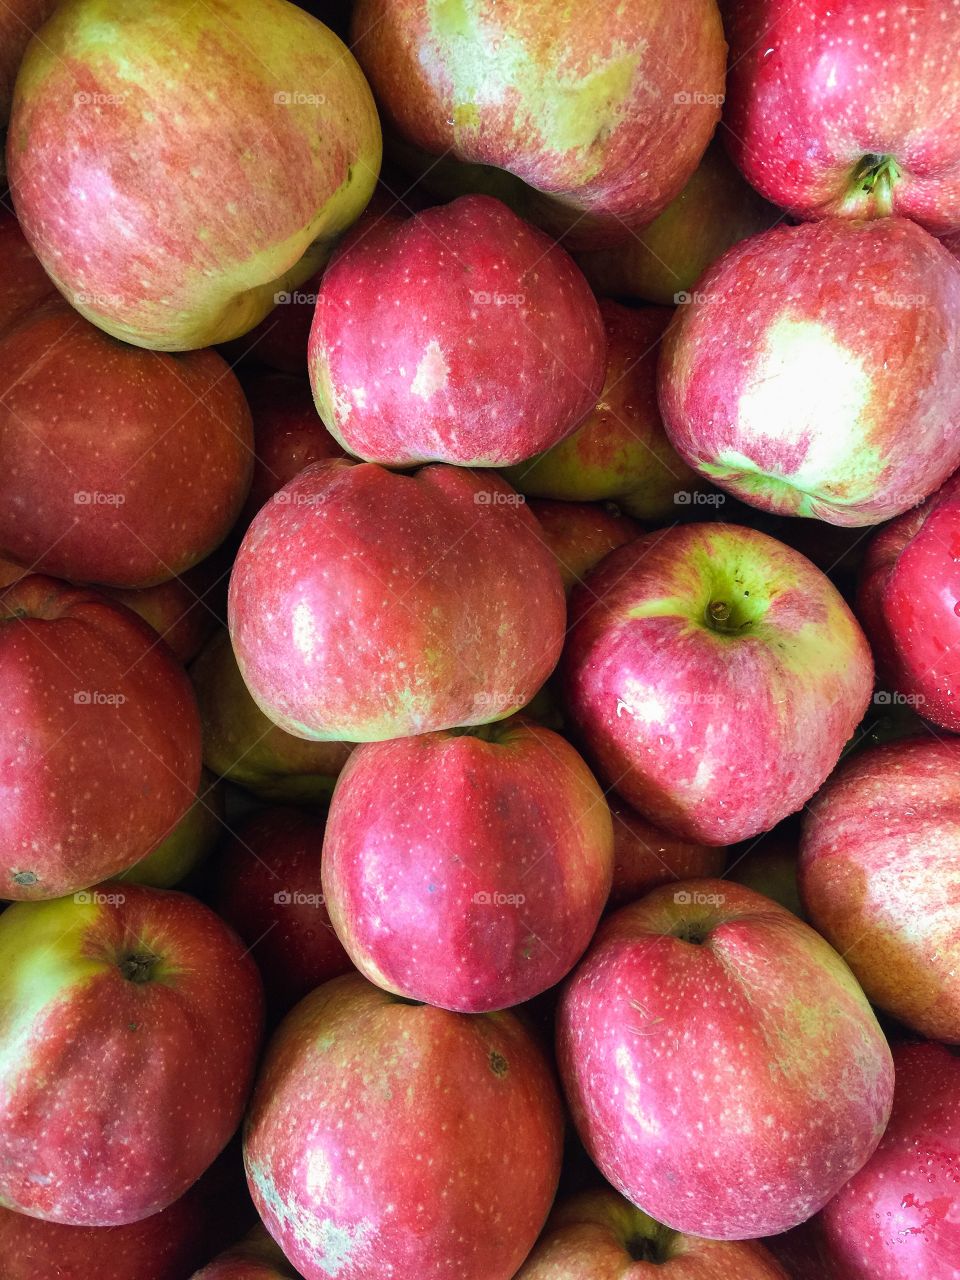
[{"xmin": 576, "ymin": 141, "xmax": 783, "ymax": 306}]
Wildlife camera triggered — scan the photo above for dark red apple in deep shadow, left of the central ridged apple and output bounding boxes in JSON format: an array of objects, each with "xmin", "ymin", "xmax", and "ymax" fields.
[{"xmin": 210, "ymin": 808, "xmax": 352, "ymax": 1014}]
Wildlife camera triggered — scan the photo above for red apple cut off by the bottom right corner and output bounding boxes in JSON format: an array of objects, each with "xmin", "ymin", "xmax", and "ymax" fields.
[{"xmin": 819, "ymin": 1043, "xmax": 960, "ymax": 1280}]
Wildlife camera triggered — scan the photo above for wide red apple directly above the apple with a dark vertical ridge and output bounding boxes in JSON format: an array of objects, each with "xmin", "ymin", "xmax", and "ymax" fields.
[{"xmin": 228, "ymin": 460, "xmax": 566, "ymax": 742}]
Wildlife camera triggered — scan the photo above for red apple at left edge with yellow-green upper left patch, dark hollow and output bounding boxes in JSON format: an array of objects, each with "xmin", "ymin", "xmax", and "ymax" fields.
[{"xmin": 0, "ymin": 882, "xmax": 262, "ymax": 1226}]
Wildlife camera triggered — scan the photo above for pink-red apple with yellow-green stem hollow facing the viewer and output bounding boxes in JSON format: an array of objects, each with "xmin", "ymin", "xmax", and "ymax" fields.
[{"xmin": 561, "ymin": 524, "xmax": 873, "ymax": 845}]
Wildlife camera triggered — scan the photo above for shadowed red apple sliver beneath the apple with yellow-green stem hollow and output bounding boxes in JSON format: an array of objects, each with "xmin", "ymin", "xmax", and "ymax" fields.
[{"xmin": 607, "ymin": 803, "xmax": 727, "ymax": 908}]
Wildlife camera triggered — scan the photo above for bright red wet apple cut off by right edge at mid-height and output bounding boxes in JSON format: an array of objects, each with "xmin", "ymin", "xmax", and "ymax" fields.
[{"xmin": 858, "ymin": 474, "xmax": 960, "ymax": 733}]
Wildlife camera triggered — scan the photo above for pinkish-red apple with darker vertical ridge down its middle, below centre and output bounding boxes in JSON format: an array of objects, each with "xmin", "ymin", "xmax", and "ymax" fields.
[{"xmin": 323, "ymin": 719, "xmax": 613, "ymax": 1014}]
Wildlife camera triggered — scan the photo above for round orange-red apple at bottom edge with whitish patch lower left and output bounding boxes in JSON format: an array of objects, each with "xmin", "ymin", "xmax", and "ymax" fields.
[{"xmin": 243, "ymin": 974, "xmax": 563, "ymax": 1280}]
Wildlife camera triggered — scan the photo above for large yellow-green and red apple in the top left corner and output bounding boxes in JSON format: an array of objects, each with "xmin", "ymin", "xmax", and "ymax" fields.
[{"xmin": 6, "ymin": 0, "xmax": 380, "ymax": 351}]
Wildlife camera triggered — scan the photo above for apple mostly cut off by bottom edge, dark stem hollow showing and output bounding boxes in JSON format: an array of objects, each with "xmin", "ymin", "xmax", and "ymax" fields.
[{"xmin": 516, "ymin": 1188, "xmax": 788, "ymax": 1280}]
